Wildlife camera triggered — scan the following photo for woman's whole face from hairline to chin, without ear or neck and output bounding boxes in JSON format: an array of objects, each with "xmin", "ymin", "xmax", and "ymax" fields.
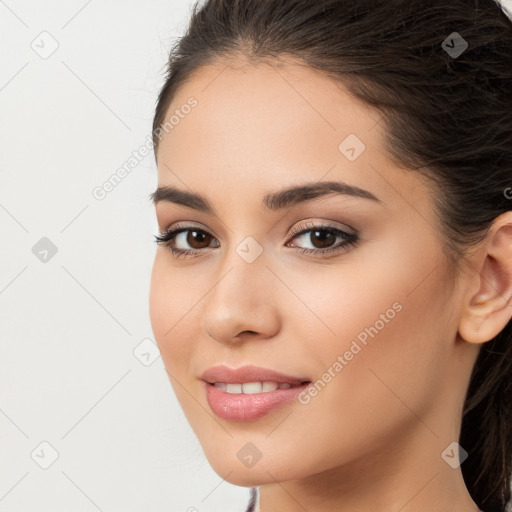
[{"xmin": 150, "ymin": 58, "xmax": 475, "ymax": 485}]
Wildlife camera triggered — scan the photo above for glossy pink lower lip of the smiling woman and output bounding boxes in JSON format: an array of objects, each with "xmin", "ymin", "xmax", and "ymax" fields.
[{"xmin": 204, "ymin": 382, "xmax": 310, "ymax": 421}]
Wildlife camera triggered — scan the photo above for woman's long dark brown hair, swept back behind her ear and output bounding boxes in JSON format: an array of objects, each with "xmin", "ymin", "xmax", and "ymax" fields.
[{"xmin": 153, "ymin": 0, "xmax": 512, "ymax": 511}]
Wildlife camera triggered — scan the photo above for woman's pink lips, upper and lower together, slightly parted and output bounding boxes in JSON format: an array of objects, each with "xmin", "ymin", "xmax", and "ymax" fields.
[{"xmin": 201, "ymin": 366, "xmax": 311, "ymax": 422}]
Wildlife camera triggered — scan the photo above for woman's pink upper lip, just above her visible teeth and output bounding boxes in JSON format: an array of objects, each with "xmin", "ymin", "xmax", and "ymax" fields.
[{"xmin": 201, "ymin": 365, "xmax": 310, "ymax": 384}]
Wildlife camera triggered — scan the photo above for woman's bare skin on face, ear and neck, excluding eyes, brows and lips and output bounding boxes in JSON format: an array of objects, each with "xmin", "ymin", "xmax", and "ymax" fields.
[{"xmin": 150, "ymin": 58, "xmax": 512, "ymax": 512}]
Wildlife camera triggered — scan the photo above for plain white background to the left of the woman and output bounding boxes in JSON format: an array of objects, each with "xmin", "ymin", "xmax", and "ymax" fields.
[{"xmin": 0, "ymin": 0, "xmax": 512, "ymax": 512}]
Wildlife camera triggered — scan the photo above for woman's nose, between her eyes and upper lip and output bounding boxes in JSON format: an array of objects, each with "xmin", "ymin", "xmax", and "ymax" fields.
[{"xmin": 201, "ymin": 244, "xmax": 281, "ymax": 344}]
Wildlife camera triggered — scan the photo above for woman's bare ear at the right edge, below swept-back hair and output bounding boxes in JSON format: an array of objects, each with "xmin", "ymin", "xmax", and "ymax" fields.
[{"xmin": 459, "ymin": 211, "xmax": 512, "ymax": 343}]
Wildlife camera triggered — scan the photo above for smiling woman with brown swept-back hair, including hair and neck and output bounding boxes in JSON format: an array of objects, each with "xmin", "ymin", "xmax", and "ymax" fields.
[{"xmin": 150, "ymin": 0, "xmax": 512, "ymax": 512}]
